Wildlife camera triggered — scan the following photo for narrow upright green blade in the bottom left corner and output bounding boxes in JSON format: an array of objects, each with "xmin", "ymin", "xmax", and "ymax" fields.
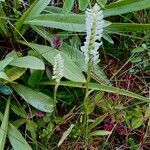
[{"xmin": 0, "ymin": 98, "xmax": 10, "ymax": 150}]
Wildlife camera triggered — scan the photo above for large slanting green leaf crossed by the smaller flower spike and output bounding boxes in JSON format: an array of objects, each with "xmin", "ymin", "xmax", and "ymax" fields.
[{"xmin": 21, "ymin": 42, "xmax": 85, "ymax": 82}]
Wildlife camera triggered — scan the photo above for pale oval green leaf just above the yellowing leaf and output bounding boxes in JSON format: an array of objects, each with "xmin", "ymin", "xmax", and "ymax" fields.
[{"xmin": 10, "ymin": 56, "xmax": 45, "ymax": 70}]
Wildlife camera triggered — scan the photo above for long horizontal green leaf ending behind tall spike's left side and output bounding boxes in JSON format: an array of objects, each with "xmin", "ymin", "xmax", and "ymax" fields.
[{"xmin": 25, "ymin": 14, "xmax": 86, "ymax": 32}]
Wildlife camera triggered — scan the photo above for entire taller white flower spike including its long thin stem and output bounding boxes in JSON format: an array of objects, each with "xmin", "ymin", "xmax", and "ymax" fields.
[{"xmin": 81, "ymin": 3, "xmax": 105, "ymax": 150}]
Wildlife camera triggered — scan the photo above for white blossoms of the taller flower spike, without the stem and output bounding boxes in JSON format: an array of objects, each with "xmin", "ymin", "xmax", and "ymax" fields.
[{"xmin": 81, "ymin": 3, "xmax": 105, "ymax": 65}]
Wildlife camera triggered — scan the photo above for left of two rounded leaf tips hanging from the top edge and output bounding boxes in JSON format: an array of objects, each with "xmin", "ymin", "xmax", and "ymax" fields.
[{"xmin": 63, "ymin": 0, "xmax": 74, "ymax": 14}]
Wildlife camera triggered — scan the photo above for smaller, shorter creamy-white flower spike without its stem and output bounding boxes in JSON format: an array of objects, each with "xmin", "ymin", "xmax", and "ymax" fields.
[{"xmin": 52, "ymin": 53, "xmax": 64, "ymax": 82}]
